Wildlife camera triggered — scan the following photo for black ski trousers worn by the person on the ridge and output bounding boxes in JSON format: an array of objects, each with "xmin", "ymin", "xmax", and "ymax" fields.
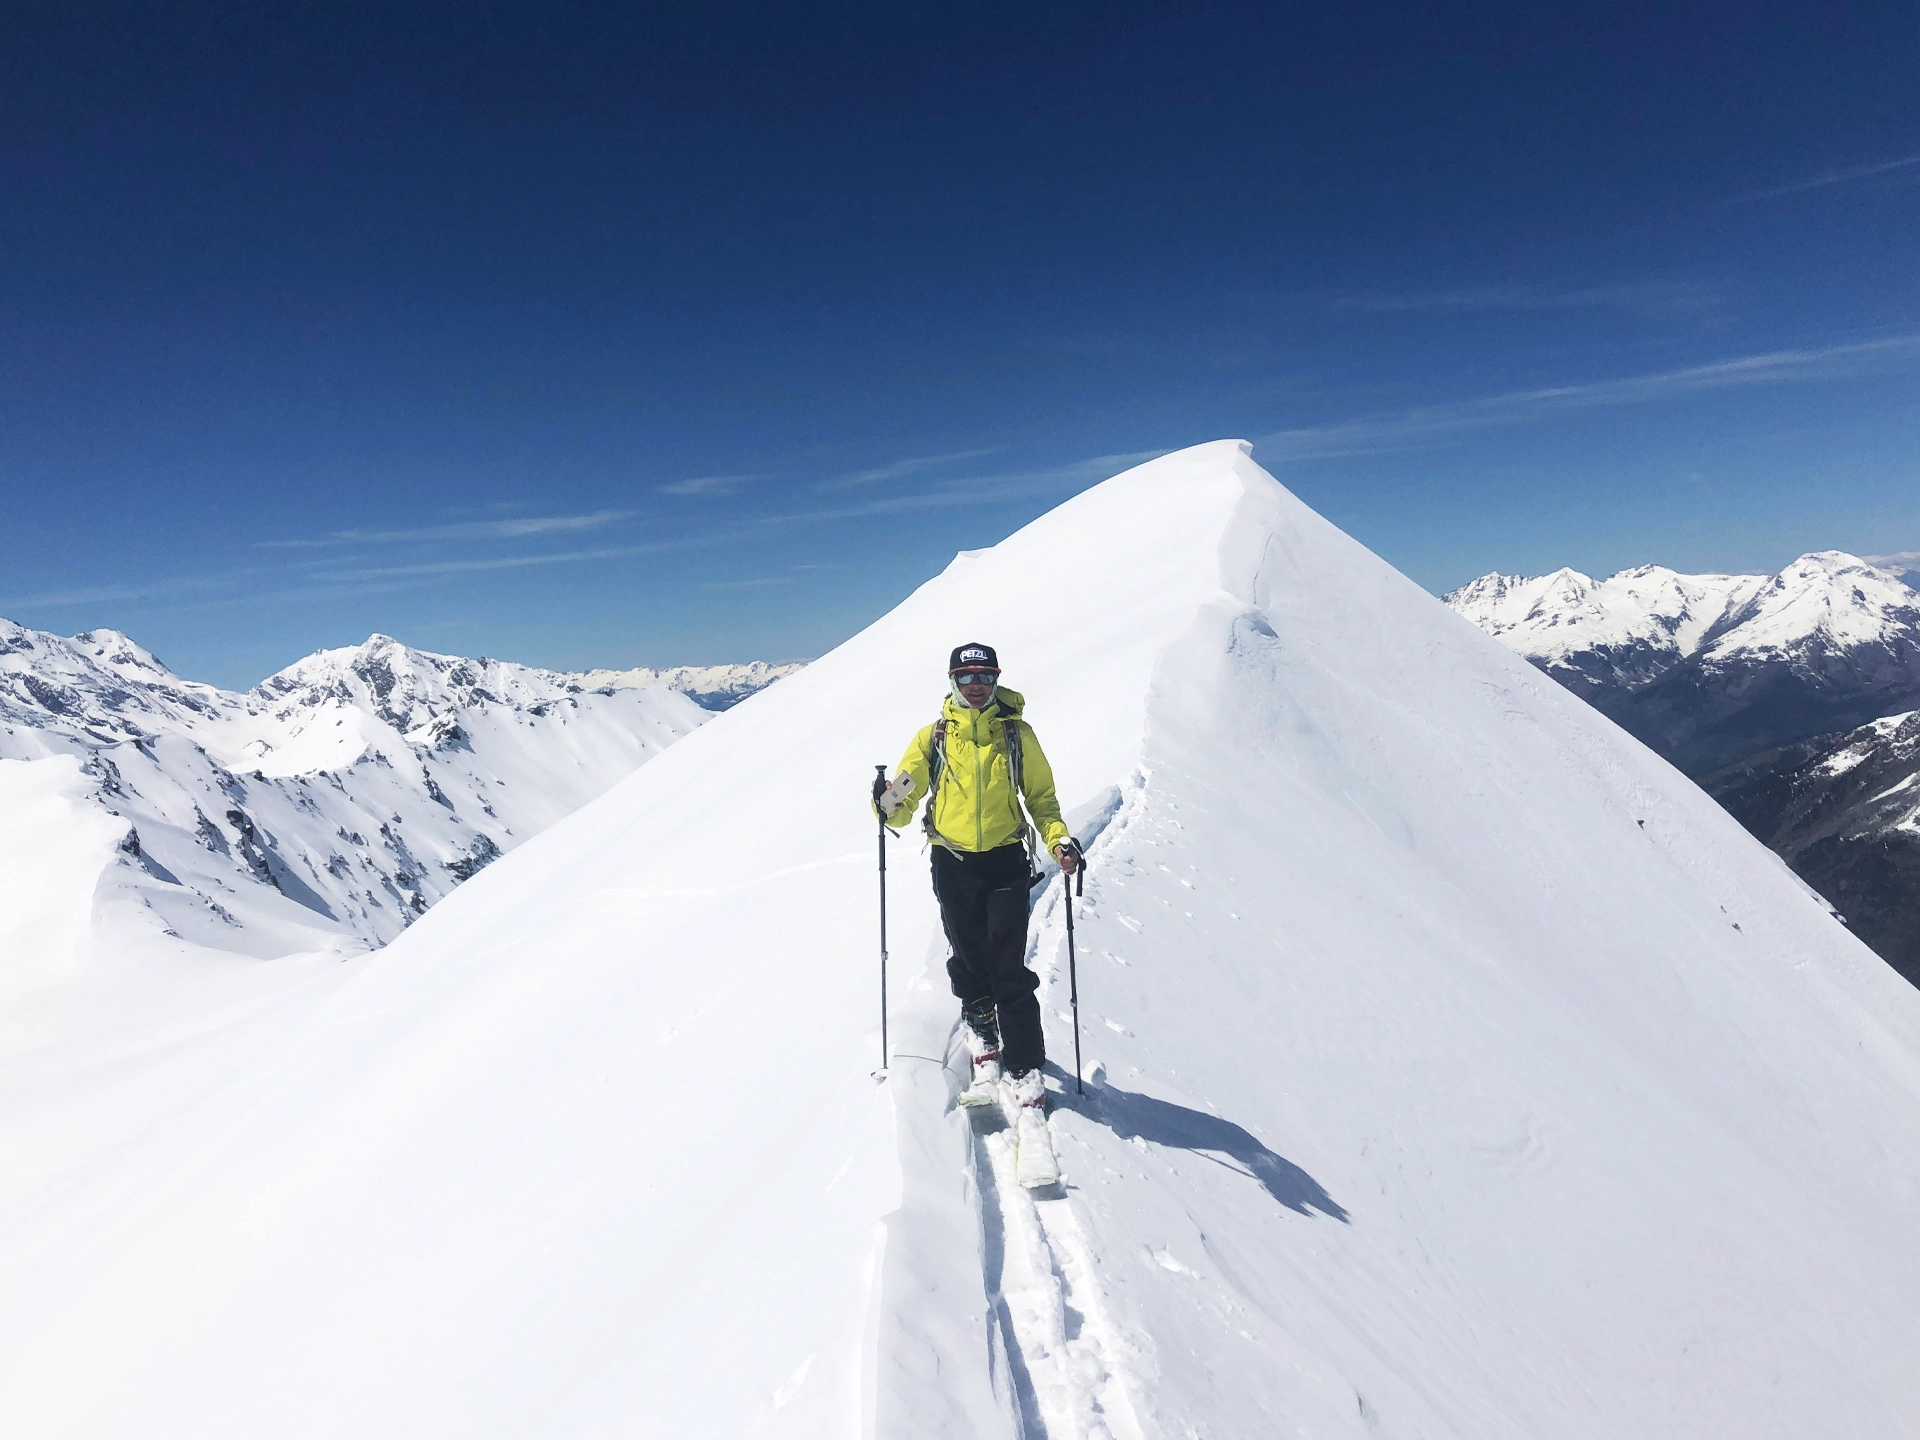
[{"xmin": 933, "ymin": 845, "xmax": 1046, "ymax": 1073}]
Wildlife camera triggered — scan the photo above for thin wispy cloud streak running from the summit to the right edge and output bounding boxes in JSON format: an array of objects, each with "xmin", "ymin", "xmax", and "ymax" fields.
[{"xmin": 1256, "ymin": 334, "xmax": 1920, "ymax": 461}]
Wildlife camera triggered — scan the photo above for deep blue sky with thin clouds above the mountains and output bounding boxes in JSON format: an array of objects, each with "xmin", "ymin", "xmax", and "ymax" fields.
[{"xmin": 0, "ymin": 4, "xmax": 1920, "ymax": 685}]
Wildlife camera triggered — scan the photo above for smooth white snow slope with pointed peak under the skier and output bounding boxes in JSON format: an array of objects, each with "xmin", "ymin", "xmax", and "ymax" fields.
[{"xmin": 0, "ymin": 442, "xmax": 1920, "ymax": 1440}]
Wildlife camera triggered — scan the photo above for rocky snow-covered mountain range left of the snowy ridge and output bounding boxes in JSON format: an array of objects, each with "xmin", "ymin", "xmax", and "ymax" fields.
[{"xmin": 0, "ymin": 620, "xmax": 795, "ymax": 971}]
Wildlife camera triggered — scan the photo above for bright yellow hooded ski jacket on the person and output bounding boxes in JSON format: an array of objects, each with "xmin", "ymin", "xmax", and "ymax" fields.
[{"xmin": 887, "ymin": 689, "xmax": 1069, "ymax": 852}]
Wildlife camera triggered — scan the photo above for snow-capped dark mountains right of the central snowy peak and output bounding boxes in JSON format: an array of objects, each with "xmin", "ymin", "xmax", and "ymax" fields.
[{"xmin": 1444, "ymin": 551, "xmax": 1920, "ymax": 985}]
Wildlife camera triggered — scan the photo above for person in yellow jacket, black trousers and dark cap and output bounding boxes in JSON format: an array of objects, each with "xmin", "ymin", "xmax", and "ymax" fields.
[{"xmin": 876, "ymin": 645, "xmax": 1079, "ymax": 1106}]
